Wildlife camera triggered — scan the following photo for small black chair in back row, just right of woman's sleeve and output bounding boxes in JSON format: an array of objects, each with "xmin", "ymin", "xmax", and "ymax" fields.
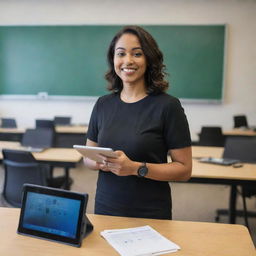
[{"xmin": 198, "ymin": 126, "xmax": 225, "ymax": 147}]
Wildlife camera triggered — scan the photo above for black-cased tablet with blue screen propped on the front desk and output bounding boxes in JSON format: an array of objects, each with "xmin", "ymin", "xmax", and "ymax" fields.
[{"xmin": 17, "ymin": 184, "xmax": 93, "ymax": 247}]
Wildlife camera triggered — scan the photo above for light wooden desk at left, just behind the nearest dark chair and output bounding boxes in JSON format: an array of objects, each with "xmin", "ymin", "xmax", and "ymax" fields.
[{"xmin": 0, "ymin": 141, "xmax": 82, "ymax": 189}]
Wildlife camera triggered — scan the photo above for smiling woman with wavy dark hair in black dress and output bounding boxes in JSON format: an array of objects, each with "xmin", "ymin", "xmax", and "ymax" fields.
[{"xmin": 85, "ymin": 26, "xmax": 192, "ymax": 219}]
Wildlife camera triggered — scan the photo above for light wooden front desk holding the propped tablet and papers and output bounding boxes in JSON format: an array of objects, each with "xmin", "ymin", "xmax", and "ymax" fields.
[{"xmin": 0, "ymin": 208, "xmax": 255, "ymax": 256}]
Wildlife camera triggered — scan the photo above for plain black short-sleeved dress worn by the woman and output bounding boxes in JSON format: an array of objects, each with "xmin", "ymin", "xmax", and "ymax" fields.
[{"xmin": 87, "ymin": 93, "xmax": 191, "ymax": 219}]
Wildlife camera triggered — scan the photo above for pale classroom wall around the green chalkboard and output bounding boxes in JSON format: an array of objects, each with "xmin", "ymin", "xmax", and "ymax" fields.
[{"xmin": 0, "ymin": 0, "xmax": 256, "ymax": 140}]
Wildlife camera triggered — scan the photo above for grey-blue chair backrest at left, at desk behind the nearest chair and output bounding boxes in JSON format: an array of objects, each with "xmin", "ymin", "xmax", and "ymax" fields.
[{"xmin": 21, "ymin": 128, "xmax": 54, "ymax": 148}]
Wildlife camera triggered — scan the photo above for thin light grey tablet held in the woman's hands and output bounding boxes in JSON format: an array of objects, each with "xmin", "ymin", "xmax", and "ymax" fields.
[{"xmin": 73, "ymin": 145, "xmax": 117, "ymax": 163}]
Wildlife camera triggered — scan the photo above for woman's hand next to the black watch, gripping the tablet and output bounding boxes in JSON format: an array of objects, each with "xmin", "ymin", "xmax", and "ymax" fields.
[{"xmin": 101, "ymin": 150, "xmax": 136, "ymax": 176}]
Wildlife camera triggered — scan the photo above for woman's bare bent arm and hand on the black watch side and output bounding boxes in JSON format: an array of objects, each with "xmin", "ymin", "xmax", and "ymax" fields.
[{"xmin": 106, "ymin": 147, "xmax": 192, "ymax": 181}]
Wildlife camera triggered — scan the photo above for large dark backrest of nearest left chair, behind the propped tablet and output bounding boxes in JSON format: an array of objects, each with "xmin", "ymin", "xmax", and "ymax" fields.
[{"xmin": 3, "ymin": 149, "xmax": 47, "ymax": 207}]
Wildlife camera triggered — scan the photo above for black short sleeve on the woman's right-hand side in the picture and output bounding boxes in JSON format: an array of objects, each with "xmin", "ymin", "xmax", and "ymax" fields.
[{"xmin": 164, "ymin": 98, "xmax": 191, "ymax": 150}]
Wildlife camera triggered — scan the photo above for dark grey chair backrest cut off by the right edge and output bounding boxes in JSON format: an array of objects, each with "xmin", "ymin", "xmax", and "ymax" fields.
[{"xmin": 223, "ymin": 136, "xmax": 256, "ymax": 163}]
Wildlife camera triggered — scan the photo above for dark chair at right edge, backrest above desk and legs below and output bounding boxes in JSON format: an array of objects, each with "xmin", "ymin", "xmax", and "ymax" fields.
[{"xmin": 215, "ymin": 137, "xmax": 256, "ymax": 228}]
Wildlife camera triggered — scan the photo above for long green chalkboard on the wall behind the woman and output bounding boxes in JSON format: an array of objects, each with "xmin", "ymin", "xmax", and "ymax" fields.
[{"xmin": 0, "ymin": 25, "xmax": 225, "ymax": 100}]
